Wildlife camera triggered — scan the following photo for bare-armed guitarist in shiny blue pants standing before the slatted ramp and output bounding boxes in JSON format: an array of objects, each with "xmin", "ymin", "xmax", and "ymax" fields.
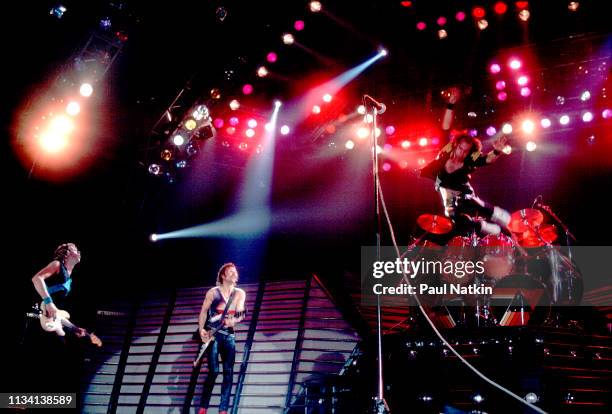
[{"xmin": 198, "ymin": 263, "xmax": 246, "ymax": 414}]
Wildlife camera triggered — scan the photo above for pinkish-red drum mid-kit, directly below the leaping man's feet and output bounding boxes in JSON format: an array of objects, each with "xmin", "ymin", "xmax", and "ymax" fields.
[{"xmin": 478, "ymin": 234, "xmax": 514, "ymax": 281}]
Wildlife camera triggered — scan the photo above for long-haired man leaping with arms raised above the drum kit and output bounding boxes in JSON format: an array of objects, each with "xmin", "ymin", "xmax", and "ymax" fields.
[{"xmin": 421, "ymin": 88, "xmax": 510, "ymax": 235}]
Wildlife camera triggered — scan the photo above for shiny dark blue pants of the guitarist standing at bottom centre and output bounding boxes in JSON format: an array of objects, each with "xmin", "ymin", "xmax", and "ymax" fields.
[{"xmin": 200, "ymin": 333, "xmax": 236, "ymax": 411}]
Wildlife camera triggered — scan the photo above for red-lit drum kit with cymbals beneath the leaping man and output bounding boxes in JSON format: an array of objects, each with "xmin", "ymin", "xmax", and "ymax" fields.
[{"xmin": 408, "ymin": 204, "xmax": 582, "ymax": 326}]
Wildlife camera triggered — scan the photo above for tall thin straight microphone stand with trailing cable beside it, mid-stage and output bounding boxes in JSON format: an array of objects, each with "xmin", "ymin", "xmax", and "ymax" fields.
[{"xmin": 364, "ymin": 98, "xmax": 390, "ymax": 414}]
